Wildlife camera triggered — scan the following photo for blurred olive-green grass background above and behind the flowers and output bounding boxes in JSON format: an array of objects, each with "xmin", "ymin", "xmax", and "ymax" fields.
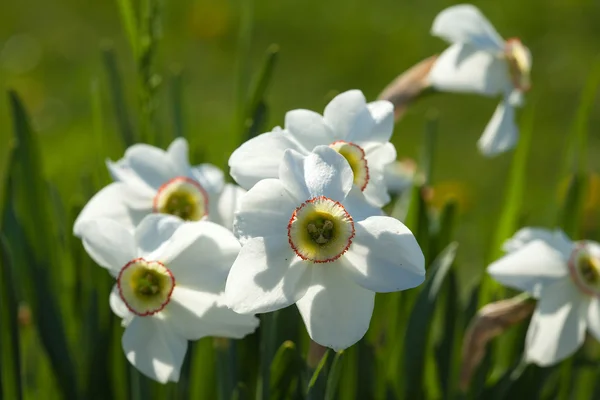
[{"xmin": 0, "ymin": 0, "xmax": 600, "ymax": 296}]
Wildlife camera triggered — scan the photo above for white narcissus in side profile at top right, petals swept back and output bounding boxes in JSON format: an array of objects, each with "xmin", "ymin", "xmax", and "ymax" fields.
[{"xmin": 429, "ymin": 4, "xmax": 531, "ymax": 156}]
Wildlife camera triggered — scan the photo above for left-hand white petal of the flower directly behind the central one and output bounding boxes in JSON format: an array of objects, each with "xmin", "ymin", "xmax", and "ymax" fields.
[{"xmin": 229, "ymin": 131, "xmax": 306, "ymax": 190}]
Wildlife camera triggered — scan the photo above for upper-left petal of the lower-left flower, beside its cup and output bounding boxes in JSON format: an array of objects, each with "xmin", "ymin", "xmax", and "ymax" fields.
[{"xmin": 80, "ymin": 219, "xmax": 137, "ymax": 276}]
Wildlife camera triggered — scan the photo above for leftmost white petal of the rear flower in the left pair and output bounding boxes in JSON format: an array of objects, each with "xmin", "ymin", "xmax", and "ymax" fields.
[{"xmin": 73, "ymin": 182, "xmax": 152, "ymax": 237}]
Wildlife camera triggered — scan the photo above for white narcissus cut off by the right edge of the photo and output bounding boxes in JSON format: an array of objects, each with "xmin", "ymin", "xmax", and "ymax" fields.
[{"xmin": 488, "ymin": 228, "xmax": 600, "ymax": 366}]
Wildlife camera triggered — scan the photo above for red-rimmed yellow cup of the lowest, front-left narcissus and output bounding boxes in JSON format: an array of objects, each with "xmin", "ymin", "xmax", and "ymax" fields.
[{"xmin": 117, "ymin": 258, "xmax": 175, "ymax": 317}]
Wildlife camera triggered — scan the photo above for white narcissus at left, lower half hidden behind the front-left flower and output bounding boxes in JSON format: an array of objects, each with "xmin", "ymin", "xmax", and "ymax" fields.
[{"xmin": 73, "ymin": 138, "xmax": 244, "ymax": 236}]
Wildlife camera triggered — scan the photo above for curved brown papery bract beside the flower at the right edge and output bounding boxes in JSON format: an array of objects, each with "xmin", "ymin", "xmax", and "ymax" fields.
[{"xmin": 460, "ymin": 295, "xmax": 535, "ymax": 391}]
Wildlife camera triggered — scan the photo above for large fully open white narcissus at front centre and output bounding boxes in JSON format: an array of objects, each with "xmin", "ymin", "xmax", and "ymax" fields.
[{"xmin": 225, "ymin": 146, "xmax": 425, "ymax": 350}]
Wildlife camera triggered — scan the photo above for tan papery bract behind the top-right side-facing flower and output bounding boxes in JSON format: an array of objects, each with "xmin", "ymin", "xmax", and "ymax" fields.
[{"xmin": 378, "ymin": 55, "xmax": 438, "ymax": 121}]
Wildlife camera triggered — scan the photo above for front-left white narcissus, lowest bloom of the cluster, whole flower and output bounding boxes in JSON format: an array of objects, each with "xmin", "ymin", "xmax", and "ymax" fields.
[{"xmin": 80, "ymin": 214, "xmax": 258, "ymax": 383}]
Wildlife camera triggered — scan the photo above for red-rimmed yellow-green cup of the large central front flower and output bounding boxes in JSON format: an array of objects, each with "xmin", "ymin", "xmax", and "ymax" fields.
[{"xmin": 288, "ymin": 196, "xmax": 354, "ymax": 263}]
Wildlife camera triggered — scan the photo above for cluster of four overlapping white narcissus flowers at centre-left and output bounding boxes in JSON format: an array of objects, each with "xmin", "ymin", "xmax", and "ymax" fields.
[{"xmin": 74, "ymin": 90, "xmax": 425, "ymax": 382}]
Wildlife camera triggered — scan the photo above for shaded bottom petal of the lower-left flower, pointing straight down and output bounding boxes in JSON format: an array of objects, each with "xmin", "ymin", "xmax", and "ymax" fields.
[{"xmin": 121, "ymin": 317, "xmax": 187, "ymax": 383}]
